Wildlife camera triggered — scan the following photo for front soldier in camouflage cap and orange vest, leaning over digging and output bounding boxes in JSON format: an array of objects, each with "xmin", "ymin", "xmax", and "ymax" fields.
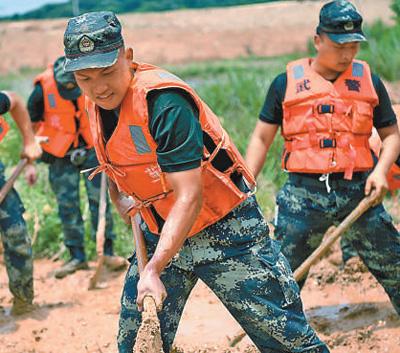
[{"xmin": 64, "ymin": 12, "xmax": 328, "ymax": 353}]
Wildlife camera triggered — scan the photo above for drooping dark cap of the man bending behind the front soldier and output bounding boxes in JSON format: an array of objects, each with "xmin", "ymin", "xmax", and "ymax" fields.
[{"xmin": 53, "ymin": 56, "xmax": 81, "ymax": 100}]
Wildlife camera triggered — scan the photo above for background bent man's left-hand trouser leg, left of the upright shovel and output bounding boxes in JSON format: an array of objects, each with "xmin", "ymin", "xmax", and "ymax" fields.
[{"xmin": 49, "ymin": 157, "xmax": 84, "ymax": 254}]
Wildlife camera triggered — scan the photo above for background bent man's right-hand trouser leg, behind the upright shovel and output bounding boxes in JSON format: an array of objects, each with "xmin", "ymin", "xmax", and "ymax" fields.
[{"xmin": 80, "ymin": 148, "xmax": 115, "ymax": 248}]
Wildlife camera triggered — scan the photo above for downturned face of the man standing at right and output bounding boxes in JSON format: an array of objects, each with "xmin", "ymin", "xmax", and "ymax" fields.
[{"xmin": 314, "ymin": 34, "xmax": 360, "ymax": 74}]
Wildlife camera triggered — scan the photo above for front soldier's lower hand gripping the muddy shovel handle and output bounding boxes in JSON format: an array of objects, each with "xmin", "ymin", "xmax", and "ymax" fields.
[{"xmin": 136, "ymin": 268, "xmax": 167, "ymax": 311}]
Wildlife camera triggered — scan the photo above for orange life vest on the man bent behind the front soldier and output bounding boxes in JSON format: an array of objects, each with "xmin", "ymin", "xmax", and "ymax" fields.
[{"xmin": 34, "ymin": 66, "xmax": 93, "ymax": 158}]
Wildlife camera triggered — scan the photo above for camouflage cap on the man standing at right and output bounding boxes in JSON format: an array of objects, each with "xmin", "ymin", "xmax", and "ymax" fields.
[{"xmin": 317, "ymin": 0, "xmax": 367, "ymax": 44}]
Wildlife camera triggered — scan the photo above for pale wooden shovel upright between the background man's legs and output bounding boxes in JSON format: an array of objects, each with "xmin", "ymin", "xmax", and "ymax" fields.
[{"xmin": 88, "ymin": 172, "xmax": 107, "ymax": 290}]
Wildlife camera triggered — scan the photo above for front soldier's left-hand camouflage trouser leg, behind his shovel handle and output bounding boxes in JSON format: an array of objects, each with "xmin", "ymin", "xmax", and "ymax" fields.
[{"xmin": 118, "ymin": 230, "xmax": 197, "ymax": 353}]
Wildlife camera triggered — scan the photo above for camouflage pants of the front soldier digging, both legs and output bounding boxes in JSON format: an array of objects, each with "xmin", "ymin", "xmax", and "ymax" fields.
[{"xmin": 118, "ymin": 198, "xmax": 329, "ymax": 353}]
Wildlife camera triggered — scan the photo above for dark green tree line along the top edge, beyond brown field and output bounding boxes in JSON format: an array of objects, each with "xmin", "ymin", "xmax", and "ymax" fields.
[{"xmin": 0, "ymin": 0, "xmax": 276, "ymax": 21}]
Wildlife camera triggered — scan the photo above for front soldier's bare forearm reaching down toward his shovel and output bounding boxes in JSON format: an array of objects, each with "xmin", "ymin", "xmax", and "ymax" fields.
[{"xmin": 146, "ymin": 195, "xmax": 202, "ymax": 275}]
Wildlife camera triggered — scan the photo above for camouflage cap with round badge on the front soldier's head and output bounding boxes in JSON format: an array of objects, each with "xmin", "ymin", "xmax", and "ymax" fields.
[{"xmin": 64, "ymin": 11, "xmax": 124, "ymax": 72}]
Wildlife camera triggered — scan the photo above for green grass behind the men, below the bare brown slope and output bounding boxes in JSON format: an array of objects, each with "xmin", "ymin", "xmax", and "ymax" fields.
[{"xmin": 0, "ymin": 15, "xmax": 400, "ymax": 256}]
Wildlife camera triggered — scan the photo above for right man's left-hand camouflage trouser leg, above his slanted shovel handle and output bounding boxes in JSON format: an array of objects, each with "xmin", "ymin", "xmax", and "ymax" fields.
[{"xmin": 275, "ymin": 181, "xmax": 336, "ymax": 289}]
